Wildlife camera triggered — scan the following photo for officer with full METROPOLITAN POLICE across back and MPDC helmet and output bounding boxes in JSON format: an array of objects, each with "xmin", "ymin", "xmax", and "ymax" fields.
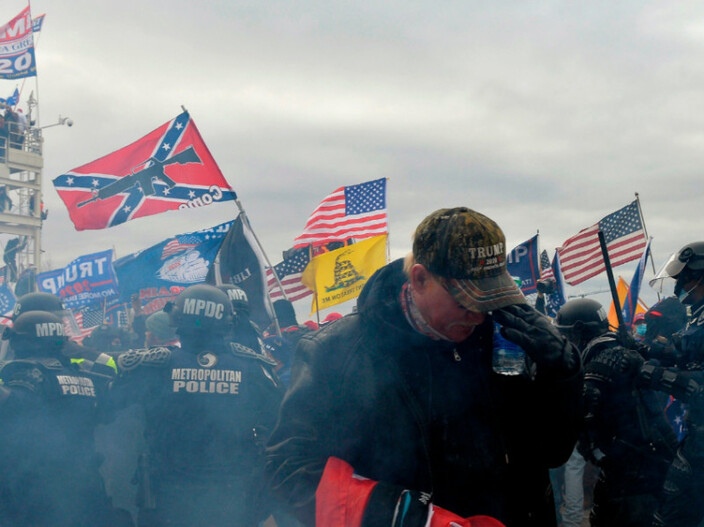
[{"xmin": 111, "ymin": 284, "xmax": 282, "ymax": 527}]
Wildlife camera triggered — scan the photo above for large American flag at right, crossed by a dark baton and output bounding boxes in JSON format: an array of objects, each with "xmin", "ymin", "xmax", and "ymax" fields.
[{"xmin": 557, "ymin": 201, "xmax": 648, "ymax": 285}]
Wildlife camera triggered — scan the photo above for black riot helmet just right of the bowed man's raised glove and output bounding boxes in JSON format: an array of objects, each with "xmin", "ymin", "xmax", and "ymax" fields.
[{"xmin": 555, "ymin": 298, "xmax": 609, "ymax": 347}]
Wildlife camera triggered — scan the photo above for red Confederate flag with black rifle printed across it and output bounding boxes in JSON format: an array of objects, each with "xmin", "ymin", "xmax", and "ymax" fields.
[{"xmin": 53, "ymin": 112, "xmax": 237, "ymax": 231}]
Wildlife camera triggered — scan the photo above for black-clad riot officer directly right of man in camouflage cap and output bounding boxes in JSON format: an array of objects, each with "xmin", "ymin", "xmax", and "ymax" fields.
[{"xmin": 558, "ymin": 299, "xmax": 677, "ymax": 527}]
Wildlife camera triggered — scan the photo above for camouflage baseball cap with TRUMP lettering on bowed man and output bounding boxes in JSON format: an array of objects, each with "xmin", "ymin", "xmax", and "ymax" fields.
[{"xmin": 413, "ymin": 207, "xmax": 526, "ymax": 313}]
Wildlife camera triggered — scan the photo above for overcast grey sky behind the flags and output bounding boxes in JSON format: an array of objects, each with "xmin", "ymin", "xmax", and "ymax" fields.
[{"xmin": 5, "ymin": 0, "xmax": 704, "ymax": 318}]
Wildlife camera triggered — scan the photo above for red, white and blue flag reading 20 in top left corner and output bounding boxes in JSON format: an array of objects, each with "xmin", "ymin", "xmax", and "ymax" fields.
[{"xmin": 0, "ymin": 6, "xmax": 37, "ymax": 79}]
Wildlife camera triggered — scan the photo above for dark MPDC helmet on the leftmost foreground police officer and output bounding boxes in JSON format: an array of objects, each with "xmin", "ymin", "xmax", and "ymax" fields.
[{"xmin": 2, "ymin": 311, "xmax": 67, "ymax": 357}]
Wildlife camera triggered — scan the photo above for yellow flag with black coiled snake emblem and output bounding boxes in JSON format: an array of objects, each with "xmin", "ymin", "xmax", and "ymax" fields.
[{"xmin": 301, "ymin": 234, "xmax": 387, "ymax": 314}]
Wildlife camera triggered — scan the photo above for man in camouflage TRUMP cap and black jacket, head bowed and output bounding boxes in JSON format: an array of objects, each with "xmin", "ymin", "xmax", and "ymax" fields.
[{"xmin": 268, "ymin": 207, "xmax": 582, "ymax": 527}]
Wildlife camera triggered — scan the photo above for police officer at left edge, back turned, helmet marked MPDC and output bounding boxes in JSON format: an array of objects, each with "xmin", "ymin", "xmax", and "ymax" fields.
[{"xmin": 0, "ymin": 311, "xmax": 121, "ymax": 527}]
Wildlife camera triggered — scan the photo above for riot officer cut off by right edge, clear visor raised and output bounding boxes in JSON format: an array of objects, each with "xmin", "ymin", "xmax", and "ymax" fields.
[{"xmin": 639, "ymin": 242, "xmax": 704, "ymax": 527}]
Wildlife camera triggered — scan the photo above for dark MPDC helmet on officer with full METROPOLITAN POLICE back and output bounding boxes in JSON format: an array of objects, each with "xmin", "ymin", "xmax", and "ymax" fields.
[{"xmin": 164, "ymin": 284, "xmax": 232, "ymax": 335}]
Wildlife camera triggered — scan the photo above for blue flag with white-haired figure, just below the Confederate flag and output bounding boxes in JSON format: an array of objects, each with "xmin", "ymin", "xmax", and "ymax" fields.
[{"xmin": 114, "ymin": 221, "xmax": 233, "ymax": 315}]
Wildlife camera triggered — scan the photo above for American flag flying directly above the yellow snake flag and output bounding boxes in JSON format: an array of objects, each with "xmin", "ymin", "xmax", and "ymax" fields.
[{"xmin": 293, "ymin": 178, "xmax": 389, "ymax": 248}]
